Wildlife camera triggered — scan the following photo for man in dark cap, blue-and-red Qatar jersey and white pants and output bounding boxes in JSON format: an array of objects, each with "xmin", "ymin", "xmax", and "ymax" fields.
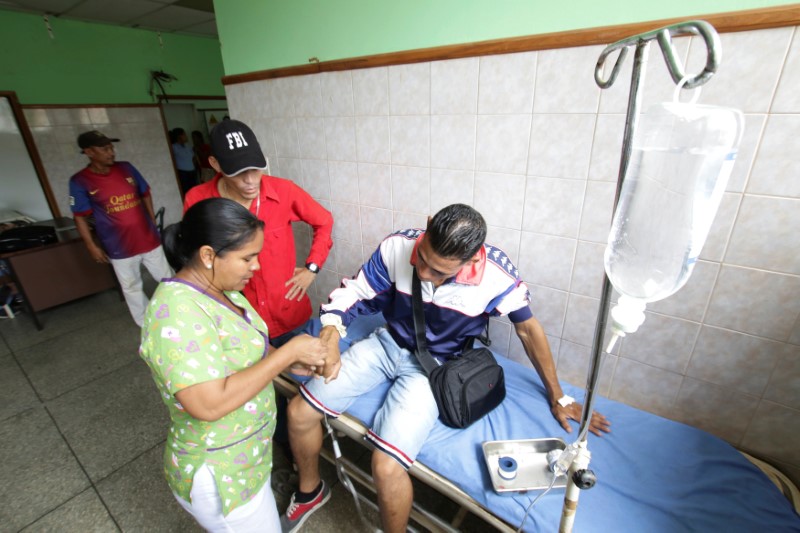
[{"xmin": 69, "ymin": 130, "xmax": 172, "ymax": 327}]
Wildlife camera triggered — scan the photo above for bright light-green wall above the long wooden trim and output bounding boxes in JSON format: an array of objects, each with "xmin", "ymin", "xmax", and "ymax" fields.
[{"xmin": 214, "ymin": 0, "xmax": 795, "ymax": 75}]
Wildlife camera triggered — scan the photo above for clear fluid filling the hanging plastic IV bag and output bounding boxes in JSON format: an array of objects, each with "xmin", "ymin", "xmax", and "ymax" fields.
[{"xmin": 605, "ymin": 148, "xmax": 735, "ymax": 302}]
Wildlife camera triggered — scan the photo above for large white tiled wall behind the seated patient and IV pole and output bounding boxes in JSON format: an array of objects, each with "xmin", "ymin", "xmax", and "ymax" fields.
[{"xmin": 227, "ymin": 27, "xmax": 800, "ymax": 480}]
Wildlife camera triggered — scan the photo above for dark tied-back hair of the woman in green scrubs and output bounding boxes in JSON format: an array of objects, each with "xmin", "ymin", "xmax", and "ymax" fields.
[{"xmin": 161, "ymin": 198, "xmax": 264, "ymax": 272}]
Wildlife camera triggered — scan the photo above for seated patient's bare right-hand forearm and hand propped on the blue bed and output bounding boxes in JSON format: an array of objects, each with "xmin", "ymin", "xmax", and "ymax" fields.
[{"xmin": 514, "ymin": 317, "xmax": 611, "ymax": 435}]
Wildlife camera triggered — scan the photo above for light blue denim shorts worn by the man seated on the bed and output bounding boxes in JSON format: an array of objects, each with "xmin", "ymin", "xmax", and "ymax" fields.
[{"xmin": 300, "ymin": 327, "xmax": 439, "ymax": 469}]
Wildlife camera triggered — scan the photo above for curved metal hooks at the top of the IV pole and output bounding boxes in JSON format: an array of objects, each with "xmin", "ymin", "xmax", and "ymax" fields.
[{"xmin": 594, "ymin": 20, "xmax": 722, "ymax": 89}]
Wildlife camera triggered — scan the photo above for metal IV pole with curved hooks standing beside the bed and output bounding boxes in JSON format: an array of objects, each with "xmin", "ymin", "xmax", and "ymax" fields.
[{"xmin": 559, "ymin": 20, "xmax": 721, "ymax": 533}]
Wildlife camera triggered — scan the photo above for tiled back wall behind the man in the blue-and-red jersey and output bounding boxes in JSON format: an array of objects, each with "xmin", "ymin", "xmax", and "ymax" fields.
[{"xmin": 24, "ymin": 106, "xmax": 183, "ymax": 225}]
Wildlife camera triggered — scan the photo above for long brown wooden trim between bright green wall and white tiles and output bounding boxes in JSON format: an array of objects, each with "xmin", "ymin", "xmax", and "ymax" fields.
[{"xmin": 222, "ymin": 4, "xmax": 800, "ymax": 85}]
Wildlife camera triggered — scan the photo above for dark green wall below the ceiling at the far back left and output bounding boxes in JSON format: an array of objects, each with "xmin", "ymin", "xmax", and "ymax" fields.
[{"xmin": 0, "ymin": 11, "xmax": 225, "ymax": 104}]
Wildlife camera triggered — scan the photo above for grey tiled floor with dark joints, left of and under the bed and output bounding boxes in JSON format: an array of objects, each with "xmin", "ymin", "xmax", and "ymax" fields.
[{"xmin": 0, "ymin": 280, "xmax": 489, "ymax": 533}]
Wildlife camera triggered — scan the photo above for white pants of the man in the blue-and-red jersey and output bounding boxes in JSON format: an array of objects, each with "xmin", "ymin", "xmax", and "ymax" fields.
[{"xmin": 110, "ymin": 246, "xmax": 173, "ymax": 327}]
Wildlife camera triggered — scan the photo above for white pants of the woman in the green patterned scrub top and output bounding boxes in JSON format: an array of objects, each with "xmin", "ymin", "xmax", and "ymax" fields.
[{"xmin": 175, "ymin": 464, "xmax": 281, "ymax": 533}]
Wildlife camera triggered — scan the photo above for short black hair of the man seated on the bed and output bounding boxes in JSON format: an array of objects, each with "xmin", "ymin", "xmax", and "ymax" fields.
[{"xmin": 425, "ymin": 204, "xmax": 486, "ymax": 262}]
